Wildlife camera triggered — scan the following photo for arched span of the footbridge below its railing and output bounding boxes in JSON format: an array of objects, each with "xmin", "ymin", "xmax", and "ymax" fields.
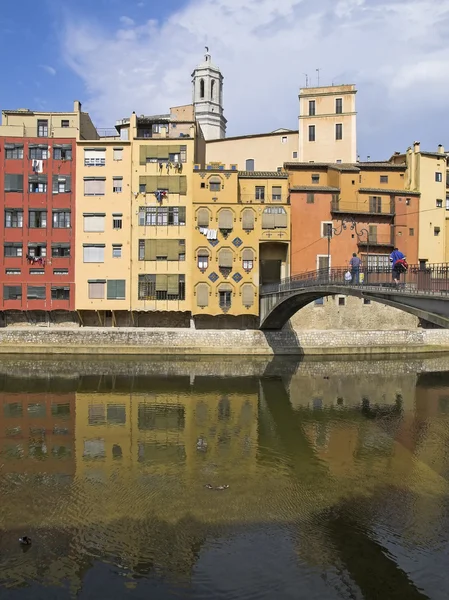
[{"xmin": 260, "ymin": 284, "xmax": 449, "ymax": 330}]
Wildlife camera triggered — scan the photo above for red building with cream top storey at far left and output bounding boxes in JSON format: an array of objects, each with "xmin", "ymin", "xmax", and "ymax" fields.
[{"xmin": 0, "ymin": 102, "xmax": 97, "ymax": 322}]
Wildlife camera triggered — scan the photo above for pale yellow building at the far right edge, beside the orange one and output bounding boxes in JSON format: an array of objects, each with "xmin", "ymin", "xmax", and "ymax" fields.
[{"xmin": 390, "ymin": 142, "xmax": 449, "ymax": 263}]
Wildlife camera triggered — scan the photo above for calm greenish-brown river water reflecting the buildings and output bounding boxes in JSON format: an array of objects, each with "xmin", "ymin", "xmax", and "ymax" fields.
[{"xmin": 0, "ymin": 357, "xmax": 449, "ymax": 600}]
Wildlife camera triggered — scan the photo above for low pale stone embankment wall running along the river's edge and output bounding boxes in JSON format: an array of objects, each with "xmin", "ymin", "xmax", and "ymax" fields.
[{"xmin": 0, "ymin": 328, "xmax": 449, "ymax": 356}]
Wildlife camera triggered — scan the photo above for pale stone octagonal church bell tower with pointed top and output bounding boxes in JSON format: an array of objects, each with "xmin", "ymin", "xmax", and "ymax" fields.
[{"xmin": 192, "ymin": 48, "xmax": 226, "ymax": 140}]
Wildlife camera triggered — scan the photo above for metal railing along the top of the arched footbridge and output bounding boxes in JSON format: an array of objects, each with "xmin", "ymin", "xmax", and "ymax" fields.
[{"xmin": 260, "ymin": 263, "xmax": 449, "ymax": 295}]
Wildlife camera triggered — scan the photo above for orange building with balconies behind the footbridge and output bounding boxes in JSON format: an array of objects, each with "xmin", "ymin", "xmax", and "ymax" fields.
[{"xmin": 284, "ymin": 162, "xmax": 420, "ymax": 275}]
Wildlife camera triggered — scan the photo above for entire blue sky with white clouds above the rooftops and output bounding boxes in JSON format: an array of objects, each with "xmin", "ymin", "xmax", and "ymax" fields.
[{"xmin": 0, "ymin": 0, "xmax": 449, "ymax": 160}]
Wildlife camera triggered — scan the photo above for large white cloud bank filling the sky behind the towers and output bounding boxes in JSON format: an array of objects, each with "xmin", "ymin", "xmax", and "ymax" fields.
[{"xmin": 62, "ymin": 0, "xmax": 449, "ymax": 156}]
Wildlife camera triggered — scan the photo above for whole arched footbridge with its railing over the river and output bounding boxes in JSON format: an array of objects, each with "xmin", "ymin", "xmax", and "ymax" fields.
[{"xmin": 260, "ymin": 264, "xmax": 449, "ymax": 330}]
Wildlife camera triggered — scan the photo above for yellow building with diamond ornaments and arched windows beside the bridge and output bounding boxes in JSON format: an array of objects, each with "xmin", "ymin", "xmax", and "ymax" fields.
[{"xmin": 192, "ymin": 163, "xmax": 290, "ymax": 319}]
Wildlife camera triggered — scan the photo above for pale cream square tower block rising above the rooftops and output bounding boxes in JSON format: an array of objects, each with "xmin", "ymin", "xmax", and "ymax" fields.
[{"xmin": 299, "ymin": 85, "xmax": 357, "ymax": 163}]
